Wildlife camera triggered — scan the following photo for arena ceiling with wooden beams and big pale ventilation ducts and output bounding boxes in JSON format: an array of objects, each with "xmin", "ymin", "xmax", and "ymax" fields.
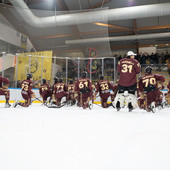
[{"xmin": 0, "ymin": 0, "xmax": 170, "ymax": 55}]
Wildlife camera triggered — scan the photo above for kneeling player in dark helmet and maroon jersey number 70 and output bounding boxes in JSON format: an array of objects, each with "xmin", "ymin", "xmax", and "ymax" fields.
[{"xmin": 139, "ymin": 66, "xmax": 165, "ymax": 113}]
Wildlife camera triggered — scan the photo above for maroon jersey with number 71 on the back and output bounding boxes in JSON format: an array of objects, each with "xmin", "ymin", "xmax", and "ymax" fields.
[{"xmin": 53, "ymin": 83, "xmax": 67, "ymax": 98}]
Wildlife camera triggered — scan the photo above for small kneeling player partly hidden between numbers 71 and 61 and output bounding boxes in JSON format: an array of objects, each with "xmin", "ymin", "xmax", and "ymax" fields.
[{"xmin": 66, "ymin": 80, "xmax": 76, "ymax": 106}]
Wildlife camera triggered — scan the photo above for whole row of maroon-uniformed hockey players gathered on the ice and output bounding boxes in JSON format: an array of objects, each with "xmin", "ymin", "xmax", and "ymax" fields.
[{"xmin": 0, "ymin": 51, "xmax": 170, "ymax": 113}]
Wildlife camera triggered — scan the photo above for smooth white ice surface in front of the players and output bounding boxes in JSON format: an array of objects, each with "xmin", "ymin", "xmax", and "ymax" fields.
[{"xmin": 0, "ymin": 104, "xmax": 170, "ymax": 170}]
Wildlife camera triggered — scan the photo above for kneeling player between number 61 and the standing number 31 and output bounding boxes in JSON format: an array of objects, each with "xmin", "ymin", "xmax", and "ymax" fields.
[{"xmin": 95, "ymin": 75, "xmax": 115, "ymax": 108}]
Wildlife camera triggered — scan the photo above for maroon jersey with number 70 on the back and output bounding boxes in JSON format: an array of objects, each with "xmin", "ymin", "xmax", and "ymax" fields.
[{"xmin": 139, "ymin": 74, "xmax": 165, "ymax": 92}]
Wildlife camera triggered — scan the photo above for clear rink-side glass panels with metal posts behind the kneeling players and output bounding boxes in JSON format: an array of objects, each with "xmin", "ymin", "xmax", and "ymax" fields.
[{"xmin": 0, "ymin": 52, "xmax": 117, "ymax": 88}]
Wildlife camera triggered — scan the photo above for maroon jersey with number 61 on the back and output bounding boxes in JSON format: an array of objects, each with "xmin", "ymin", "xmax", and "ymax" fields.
[{"xmin": 75, "ymin": 78, "xmax": 92, "ymax": 91}]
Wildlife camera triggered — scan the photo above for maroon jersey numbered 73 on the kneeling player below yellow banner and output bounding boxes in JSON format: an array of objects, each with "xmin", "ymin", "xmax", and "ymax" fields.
[{"xmin": 21, "ymin": 80, "xmax": 33, "ymax": 95}]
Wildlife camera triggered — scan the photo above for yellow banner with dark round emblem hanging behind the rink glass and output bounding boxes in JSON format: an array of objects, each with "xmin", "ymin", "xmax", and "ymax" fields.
[{"xmin": 15, "ymin": 51, "xmax": 52, "ymax": 80}]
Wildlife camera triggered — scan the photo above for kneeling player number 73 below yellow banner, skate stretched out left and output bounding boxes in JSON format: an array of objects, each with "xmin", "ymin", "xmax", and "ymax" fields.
[{"xmin": 14, "ymin": 74, "xmax": 35, "ymax": 107}]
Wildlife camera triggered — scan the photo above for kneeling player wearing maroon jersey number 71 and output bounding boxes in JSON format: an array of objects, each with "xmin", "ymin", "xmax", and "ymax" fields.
[{"xmin": 53, "ymin": 78, "xmax": 67, "ymax": 106}]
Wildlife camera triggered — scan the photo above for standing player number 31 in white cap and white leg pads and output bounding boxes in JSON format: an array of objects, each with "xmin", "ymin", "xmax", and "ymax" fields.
[{"xmin": 114, "ymin": 51, "xmax": 140, "ymax": 111}]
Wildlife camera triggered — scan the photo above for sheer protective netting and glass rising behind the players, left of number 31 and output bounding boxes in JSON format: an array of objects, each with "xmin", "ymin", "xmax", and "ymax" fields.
[{"xmin": 0, "ymin": 0, "xmax": 116, "ymax": 87}]
